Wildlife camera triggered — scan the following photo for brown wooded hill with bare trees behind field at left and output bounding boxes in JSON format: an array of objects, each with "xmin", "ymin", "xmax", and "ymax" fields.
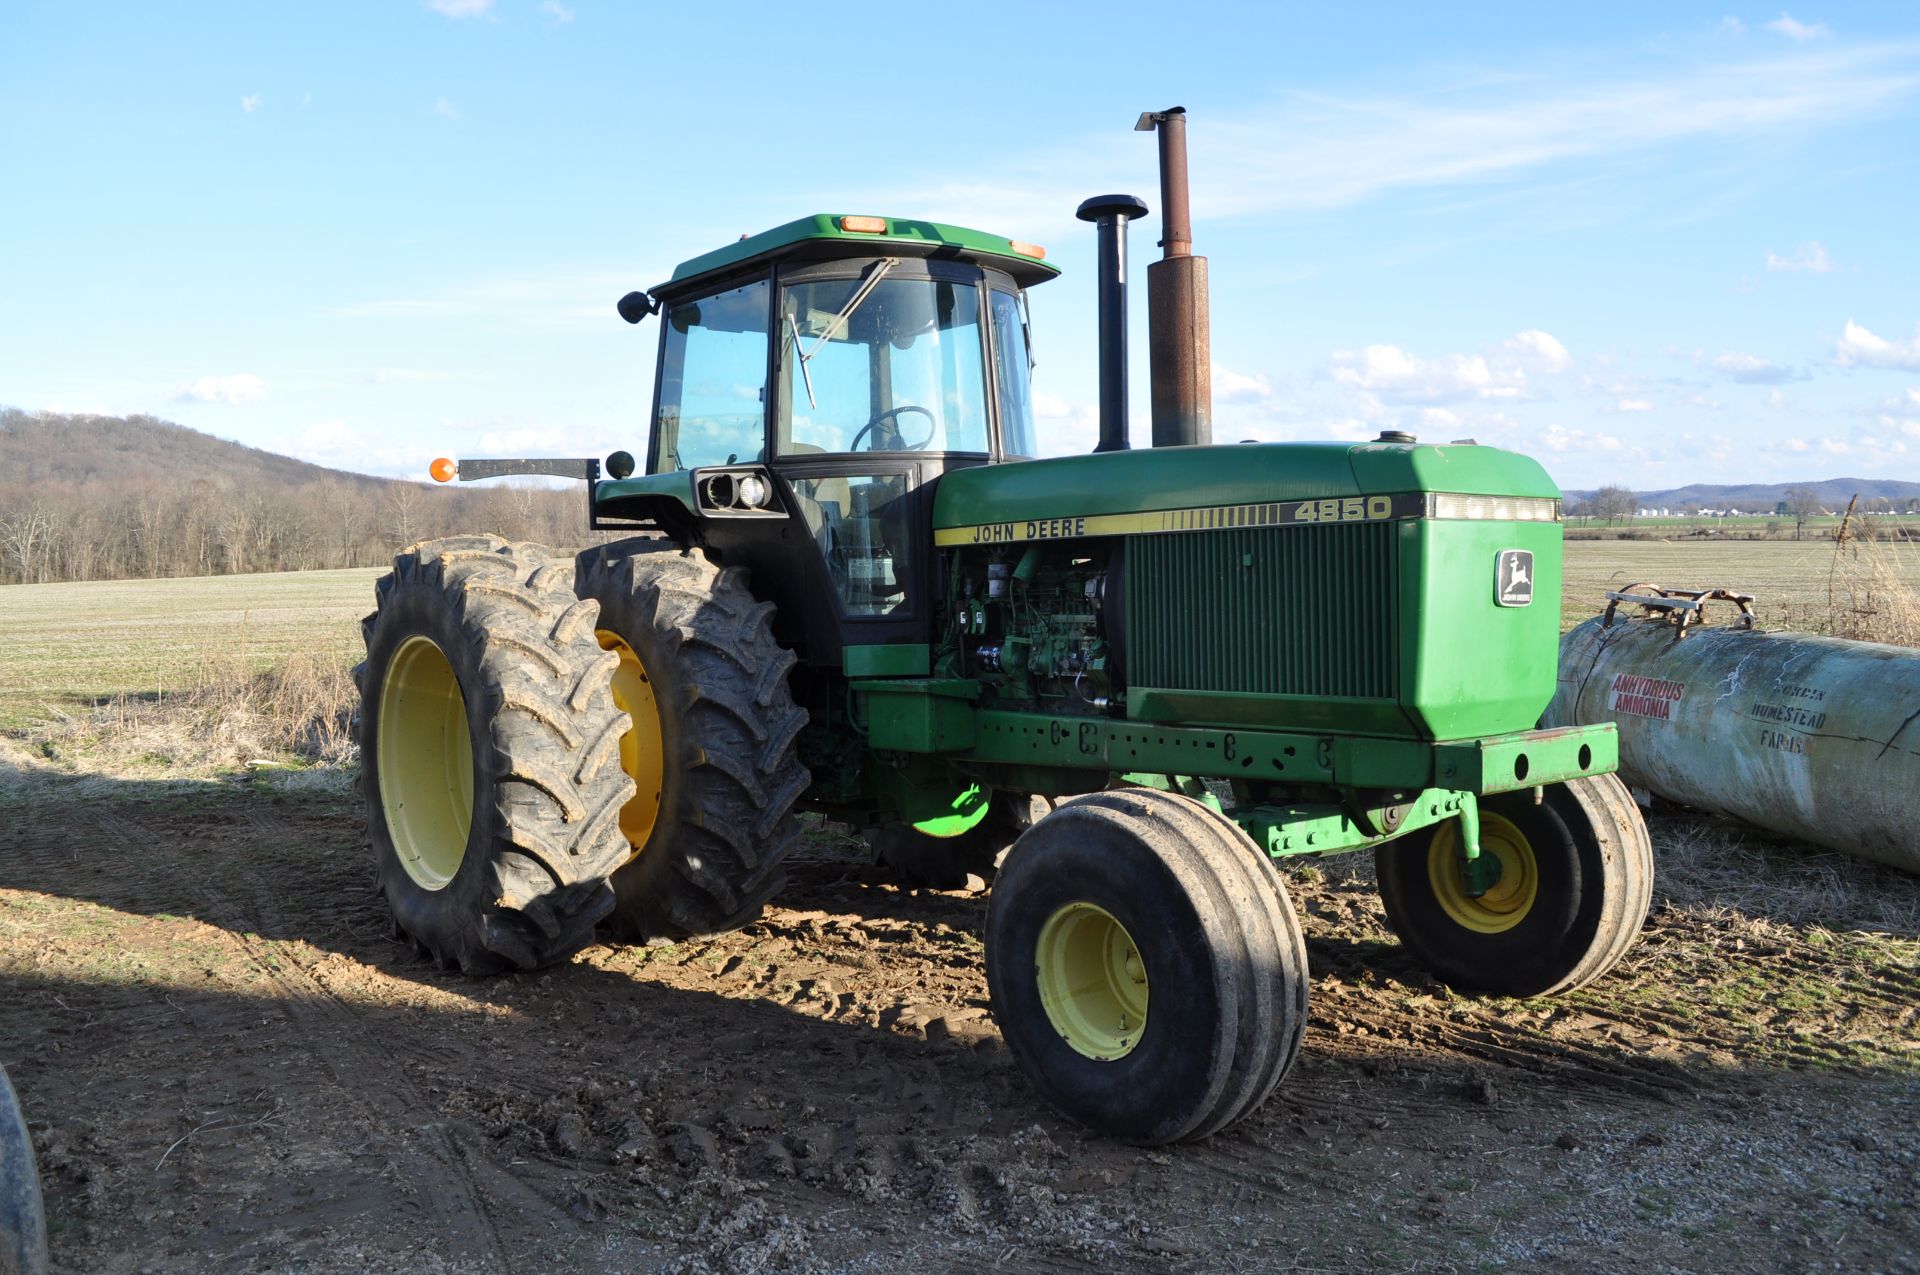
[{"xmin": 0, "ymin": 411, "xmax": 589, "ymax": 584}]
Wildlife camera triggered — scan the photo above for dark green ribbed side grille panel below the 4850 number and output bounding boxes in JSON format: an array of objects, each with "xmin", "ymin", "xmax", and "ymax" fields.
[{"xmin": 1127, "ymin": 522, "xmax": 1400, "ymax": 699}]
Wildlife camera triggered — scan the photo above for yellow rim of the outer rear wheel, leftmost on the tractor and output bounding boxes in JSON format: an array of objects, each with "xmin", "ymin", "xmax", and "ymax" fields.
[{"xmin": 378, "ymin": 636, "xmax": 474, "ymax": 889}]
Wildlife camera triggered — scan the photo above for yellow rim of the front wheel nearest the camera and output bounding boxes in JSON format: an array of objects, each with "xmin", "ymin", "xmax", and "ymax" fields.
[{"xmin": 1033, "ymin": 902, "xmax": 1146, "ymax": 1062}]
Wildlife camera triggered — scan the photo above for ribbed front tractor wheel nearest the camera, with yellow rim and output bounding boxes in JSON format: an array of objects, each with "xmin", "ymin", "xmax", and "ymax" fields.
[{"xmin": 987, "ymin": 789, "xmax": 1308, "ymax": 1144}]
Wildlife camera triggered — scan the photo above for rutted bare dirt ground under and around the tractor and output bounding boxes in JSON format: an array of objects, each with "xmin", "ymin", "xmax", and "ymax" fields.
[{"xmin": 0, "ymin": 760, "xmax": 1920, "ymax": 1275}]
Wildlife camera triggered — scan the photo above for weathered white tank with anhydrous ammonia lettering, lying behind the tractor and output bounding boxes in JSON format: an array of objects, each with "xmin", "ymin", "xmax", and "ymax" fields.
[{"xmin": 1546, "ymin": 614, "xmax": 1920, "ymax": 872}]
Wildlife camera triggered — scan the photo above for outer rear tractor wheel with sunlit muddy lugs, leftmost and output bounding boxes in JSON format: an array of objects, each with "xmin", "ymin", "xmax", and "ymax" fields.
[{"xmin": 353, "ymin": 536, "xmax": 634, "ymax": 974}]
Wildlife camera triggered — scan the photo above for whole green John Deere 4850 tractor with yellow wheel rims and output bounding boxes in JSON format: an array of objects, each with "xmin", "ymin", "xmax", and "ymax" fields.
[{"xmin": 361, "ymin": 113, "xmax": 1653, "ymax": 1143}]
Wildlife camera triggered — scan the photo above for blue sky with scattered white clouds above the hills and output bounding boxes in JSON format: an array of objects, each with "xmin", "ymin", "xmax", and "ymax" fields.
[{"xmin": 0, "ymin": 0, "xmax": 1920, "ymax": 490}]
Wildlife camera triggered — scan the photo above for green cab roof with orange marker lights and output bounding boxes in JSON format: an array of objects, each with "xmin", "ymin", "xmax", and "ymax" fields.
[{"xmin": 653, "ymin": 213, "xmax": 1060, "ymax": 300}]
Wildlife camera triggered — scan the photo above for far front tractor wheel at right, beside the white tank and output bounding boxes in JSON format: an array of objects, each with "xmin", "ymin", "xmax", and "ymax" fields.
[{"xmin": 1375, "ymin": 774, "xmax": 1653, "ymax": 997}]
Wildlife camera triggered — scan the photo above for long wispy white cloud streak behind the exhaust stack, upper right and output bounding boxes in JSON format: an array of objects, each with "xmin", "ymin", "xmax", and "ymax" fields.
[{"xmin": 856, "ymin": 42, "xmax": 1920, "ymax": 234}]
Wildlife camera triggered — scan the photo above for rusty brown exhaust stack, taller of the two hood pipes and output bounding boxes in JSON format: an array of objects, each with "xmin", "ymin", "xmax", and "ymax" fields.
[{"xmin": 1133, "ymin": 106, "xmax": 1213, "ymax": 447}]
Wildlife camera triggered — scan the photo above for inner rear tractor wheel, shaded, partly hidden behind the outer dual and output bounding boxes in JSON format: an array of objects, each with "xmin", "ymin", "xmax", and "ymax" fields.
[{"xmin": 576, "ymin": 543, "xmax": 810, "ymax": 939}]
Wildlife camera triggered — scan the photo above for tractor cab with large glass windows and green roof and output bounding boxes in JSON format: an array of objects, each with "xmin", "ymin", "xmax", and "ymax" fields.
[{"xmin": 595, "ymin": 215, "xmax": 1056, "ymax": 666}]
